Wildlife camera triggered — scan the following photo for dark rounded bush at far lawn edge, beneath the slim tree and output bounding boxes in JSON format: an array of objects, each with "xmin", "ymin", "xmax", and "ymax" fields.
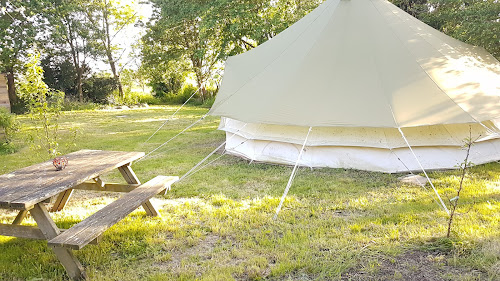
[{"xmin": 83, "ymin": 76, "xmax": 118, "ymax": 104}]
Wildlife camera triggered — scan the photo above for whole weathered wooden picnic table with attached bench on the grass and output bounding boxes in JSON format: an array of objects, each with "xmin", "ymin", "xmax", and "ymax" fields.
[{"xmin": 0, "ymin": 150, "xmax": 178, "ymax": 280}]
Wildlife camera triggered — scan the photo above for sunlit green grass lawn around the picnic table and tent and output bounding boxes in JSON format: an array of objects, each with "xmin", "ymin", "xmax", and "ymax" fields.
[{"xmin": 0, "ymin": 106, "xmax": 500, "ymax": 280}]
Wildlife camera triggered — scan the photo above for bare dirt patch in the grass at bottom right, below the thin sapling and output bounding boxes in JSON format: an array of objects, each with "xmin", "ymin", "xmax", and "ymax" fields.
[{"xmin": 342, "ymin": 248, "xmax": 485, "ymax": 281}]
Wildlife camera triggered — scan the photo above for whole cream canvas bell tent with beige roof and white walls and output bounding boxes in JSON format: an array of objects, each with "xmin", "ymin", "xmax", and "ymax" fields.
[{"xmin": 210, "ymin": 0, "xmax": 500, "ymax": 173}]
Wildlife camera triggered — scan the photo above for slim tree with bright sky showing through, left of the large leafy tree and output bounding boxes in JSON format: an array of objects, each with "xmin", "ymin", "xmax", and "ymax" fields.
[{"xmin": 85, "ymin": 0, "xmax": 138, "ymax": 98}]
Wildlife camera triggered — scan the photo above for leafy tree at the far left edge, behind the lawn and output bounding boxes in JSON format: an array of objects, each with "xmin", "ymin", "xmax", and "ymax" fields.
[{"xmin": 0, "ymin": 0, "xmax": 40, "ymax": 108}]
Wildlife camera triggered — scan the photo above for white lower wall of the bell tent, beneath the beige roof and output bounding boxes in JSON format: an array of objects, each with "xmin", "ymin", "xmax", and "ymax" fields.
[{"xmin": 219, "ymin": 117, "xmax": 500, "ymax": 173}]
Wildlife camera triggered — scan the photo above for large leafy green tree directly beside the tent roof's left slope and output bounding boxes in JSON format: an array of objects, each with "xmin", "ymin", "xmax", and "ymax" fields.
[{"xmin": 142, "ymin": 0, "xmax": 322, "ymax": 97}]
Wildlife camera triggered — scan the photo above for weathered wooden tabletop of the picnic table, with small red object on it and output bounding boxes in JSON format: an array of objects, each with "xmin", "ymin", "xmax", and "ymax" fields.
[{"xmin": 0, "ymin": 150, "xmax": 144, "ymax": 210}]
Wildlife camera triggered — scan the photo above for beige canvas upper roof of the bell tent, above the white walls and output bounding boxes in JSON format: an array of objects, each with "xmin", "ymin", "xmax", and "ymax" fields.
[{"xmin": 210, "ymin": 0, "xmax": 500, "ymax": 128}]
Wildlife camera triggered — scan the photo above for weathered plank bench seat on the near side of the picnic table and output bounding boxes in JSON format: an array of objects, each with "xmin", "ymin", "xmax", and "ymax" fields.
[{"xmin": 49, "ymin": 176, "xmax": 179, "ymax": 250}]
